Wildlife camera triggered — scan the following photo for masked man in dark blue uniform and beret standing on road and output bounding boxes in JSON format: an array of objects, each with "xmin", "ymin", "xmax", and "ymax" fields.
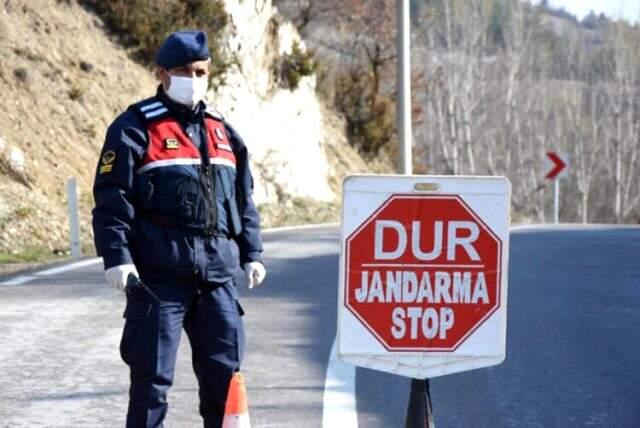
[{"xmin": 93, "ymin": 31, "xmax": 266, "ymax": 427}]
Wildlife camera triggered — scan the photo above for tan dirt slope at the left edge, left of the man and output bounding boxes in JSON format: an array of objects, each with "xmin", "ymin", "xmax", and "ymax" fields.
[{"xmin": 0, "ymin": 0, "xmax": 155, "ymax": 252}]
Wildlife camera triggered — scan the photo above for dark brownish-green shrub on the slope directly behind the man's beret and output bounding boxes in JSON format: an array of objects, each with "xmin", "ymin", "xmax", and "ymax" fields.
[{"xmin": 80, "ymin": 0, "xmax": 230, "ymax": 87}]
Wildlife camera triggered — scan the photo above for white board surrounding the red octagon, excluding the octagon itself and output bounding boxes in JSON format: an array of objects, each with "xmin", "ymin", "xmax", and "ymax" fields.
[{"xmin": 338, "ymin": 175, "xmax": 511, "ymax": 378}]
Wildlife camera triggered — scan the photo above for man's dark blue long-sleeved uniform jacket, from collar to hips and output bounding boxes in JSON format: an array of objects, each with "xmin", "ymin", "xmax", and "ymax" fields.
[{"xmin": 93, "ymin": 90, "xmax": 262, "ymax": 282}]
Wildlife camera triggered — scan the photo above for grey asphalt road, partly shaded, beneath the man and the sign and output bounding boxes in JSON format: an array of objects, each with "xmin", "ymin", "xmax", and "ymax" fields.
[{"xmin": 0, "ymin": 227, "xmax": 640, "ymax": 428}]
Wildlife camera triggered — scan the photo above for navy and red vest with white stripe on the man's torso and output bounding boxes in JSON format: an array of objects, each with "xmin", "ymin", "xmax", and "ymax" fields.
[{"xmin": 131, "ymin": 97, "xmax": 242, "ymax": 236}]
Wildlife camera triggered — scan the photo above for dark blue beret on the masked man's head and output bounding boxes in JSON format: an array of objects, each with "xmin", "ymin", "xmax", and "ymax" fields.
[{"xmin": 156, "ymin": 31, "xmax": 209, "ymax": 70}]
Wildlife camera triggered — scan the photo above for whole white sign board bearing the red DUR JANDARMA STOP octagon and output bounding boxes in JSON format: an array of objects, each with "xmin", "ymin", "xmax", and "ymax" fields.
[{"xmin": 338, "ymin": 175, "xmax": 511, "ymax": 378}]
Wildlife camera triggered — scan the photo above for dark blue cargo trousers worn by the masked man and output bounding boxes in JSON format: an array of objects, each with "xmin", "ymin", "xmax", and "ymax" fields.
[{"xmin": 120, "ymin": 275, "xmax": 244, "ymax": 428}]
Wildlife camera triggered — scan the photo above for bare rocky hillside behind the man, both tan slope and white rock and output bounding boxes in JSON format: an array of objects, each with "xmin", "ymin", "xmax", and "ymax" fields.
[{"xmin": 0, "ymin": 0, "xmax": 366, "ymax": 261}]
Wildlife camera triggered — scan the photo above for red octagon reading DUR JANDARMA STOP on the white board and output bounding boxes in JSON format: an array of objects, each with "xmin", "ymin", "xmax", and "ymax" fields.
[{"xmin": 345, "ymin": 194, "xmax": 502, "ymax": 351}]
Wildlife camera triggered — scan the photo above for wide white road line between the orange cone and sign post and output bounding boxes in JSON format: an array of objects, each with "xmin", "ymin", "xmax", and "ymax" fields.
[{"xmin": 322, "ymin": 338, "xmax": 358, "ymax": 428}]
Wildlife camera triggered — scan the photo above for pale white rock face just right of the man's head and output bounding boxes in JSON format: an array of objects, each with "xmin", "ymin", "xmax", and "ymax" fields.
[{"xmin": 211, "ymin": 0, "xmax": 337, "ymax": 203}]
